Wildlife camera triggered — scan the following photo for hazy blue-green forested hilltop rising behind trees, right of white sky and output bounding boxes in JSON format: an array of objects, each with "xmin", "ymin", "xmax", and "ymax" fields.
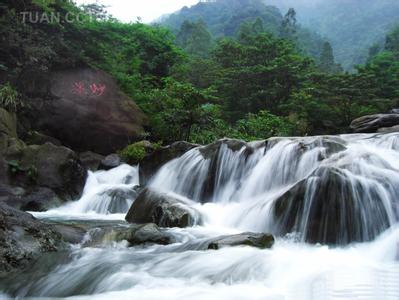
[{"xmin": 159, "ymin": 0, "xmax": 324, "ymax": 60}]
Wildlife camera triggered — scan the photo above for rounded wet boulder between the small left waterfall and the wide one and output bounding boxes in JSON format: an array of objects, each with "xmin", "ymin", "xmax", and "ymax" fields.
[{"xmin": 126, "ymin": 188, "xmax": 200, "ymax": 228}]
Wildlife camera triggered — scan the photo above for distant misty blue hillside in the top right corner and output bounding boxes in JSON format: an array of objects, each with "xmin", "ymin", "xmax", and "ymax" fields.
[{"xmin": 264, "ymin": 0, "xmax": 399, "ymax": 69}]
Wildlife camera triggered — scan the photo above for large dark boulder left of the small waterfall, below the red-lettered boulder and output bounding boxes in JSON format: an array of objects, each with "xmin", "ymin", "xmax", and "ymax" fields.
[{"xmin": 7, "ymin": 143, "xmax": 87, "ymax": 199}]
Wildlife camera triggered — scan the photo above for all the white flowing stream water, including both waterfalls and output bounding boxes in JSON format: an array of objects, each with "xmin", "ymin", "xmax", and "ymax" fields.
[{"xmin": 0, "ymin": 134, "xmax": 399, "ymax": 300}]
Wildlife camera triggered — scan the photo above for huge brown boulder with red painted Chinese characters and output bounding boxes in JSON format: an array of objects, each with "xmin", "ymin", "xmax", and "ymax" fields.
[{"xmin": 24, "ymin": 68, "xmax": 147, "ymax": 155}]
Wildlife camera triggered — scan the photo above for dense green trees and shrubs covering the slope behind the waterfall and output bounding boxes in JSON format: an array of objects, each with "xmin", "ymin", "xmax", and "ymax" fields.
[{"xmin": 0, "ymin": 0, "xmax": 399, "ymax": 146}]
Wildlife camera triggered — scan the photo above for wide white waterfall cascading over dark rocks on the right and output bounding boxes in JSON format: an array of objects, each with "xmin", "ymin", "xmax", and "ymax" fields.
[{"xmin": 150, "ymin": 134, "xmax": 399, "ymax": 244}]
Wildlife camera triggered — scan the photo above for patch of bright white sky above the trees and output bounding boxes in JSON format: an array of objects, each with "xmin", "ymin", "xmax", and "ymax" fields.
[{"xmin": 75, "ymin": 0, "xmax": 198, "ymax": 23}]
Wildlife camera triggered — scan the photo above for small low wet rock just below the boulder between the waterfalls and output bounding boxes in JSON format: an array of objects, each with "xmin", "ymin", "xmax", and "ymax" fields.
[{"xmin": 117, "ymin": 223, "xmax": 173, "ymax": 246}]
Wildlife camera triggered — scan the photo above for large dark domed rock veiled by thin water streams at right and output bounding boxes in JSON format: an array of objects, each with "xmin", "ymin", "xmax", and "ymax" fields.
[{"xmin": 273, "ymin": 167, "xmax": 390, "ymax": 245}]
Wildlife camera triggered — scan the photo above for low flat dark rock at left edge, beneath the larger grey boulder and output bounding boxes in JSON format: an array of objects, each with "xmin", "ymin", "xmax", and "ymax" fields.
[{"xmin": 0, "ymin": 186, "xmax": 62, "ymax": 211}]
